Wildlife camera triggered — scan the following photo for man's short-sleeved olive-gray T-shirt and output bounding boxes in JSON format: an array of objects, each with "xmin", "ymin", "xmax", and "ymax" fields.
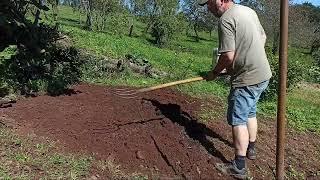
[{"xmin": 218, "ymin": 4, "xmax": 272, "ymax": 87}]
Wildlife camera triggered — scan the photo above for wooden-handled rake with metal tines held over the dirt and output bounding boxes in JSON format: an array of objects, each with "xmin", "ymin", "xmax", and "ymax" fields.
[{"xmin": 112, "ymin": 77, "xmax": 204, "ymax": 99}]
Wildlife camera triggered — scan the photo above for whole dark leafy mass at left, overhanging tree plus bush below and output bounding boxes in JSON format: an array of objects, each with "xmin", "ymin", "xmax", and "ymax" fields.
[{"xmin": 0, "ymin": 0, "xmax": 82, "ymax": 95}]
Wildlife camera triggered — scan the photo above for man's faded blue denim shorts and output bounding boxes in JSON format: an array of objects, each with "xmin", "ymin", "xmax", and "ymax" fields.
[{"xmin": 227, "ymin": 80, "xmax": 269, "ymax": 126}]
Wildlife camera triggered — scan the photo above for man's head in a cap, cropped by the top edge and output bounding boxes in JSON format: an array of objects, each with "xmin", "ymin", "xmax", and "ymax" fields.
[{"xmin": 198, "ymin": 0, "xmax": 234, "ymax": 17}]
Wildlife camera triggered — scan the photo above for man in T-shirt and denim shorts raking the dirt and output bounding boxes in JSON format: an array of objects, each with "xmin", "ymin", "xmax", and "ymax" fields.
[{"xmin": 199, "ymin": 0, "xmax": 272, "ymax": 179}]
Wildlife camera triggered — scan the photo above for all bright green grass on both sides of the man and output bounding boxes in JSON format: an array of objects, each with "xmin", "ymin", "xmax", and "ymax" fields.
[{"xmin": 54, "ymin": 7, "xmax": 320, "ymax": 132}]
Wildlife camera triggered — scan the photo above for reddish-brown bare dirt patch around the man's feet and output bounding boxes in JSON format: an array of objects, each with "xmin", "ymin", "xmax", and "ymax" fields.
[{"xmin": 0, "ymin": 84, "xmax": 320, "ymax": 179}]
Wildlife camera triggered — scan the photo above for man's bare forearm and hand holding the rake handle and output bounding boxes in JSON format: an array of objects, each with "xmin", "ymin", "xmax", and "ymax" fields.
[{"xmin": 205, "ymin": 51, "xmax": 235, "ymax": 81}]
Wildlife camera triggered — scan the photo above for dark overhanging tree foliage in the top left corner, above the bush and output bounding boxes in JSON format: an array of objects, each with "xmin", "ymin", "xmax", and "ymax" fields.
[{"xmin": 0, "ymin": 0, "xmax": 49, "ymax": 52}]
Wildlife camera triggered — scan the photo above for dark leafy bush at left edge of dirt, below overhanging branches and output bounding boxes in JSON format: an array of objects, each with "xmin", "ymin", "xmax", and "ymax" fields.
[{"xmin": 0, "ymin": 26, "xmax": 83, "ymax": 95}]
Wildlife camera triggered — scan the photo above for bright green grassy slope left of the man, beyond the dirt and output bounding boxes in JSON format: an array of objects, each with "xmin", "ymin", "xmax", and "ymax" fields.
[{"xmin": 60, "ymin": 7, "xmax": 227, "ymax": 95}]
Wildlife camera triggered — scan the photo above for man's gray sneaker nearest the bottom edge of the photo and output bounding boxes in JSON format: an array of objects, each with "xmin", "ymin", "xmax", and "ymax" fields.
[{"xmin": 216, "ymin": 160, "xmax": 247, "ymax": 179}]
